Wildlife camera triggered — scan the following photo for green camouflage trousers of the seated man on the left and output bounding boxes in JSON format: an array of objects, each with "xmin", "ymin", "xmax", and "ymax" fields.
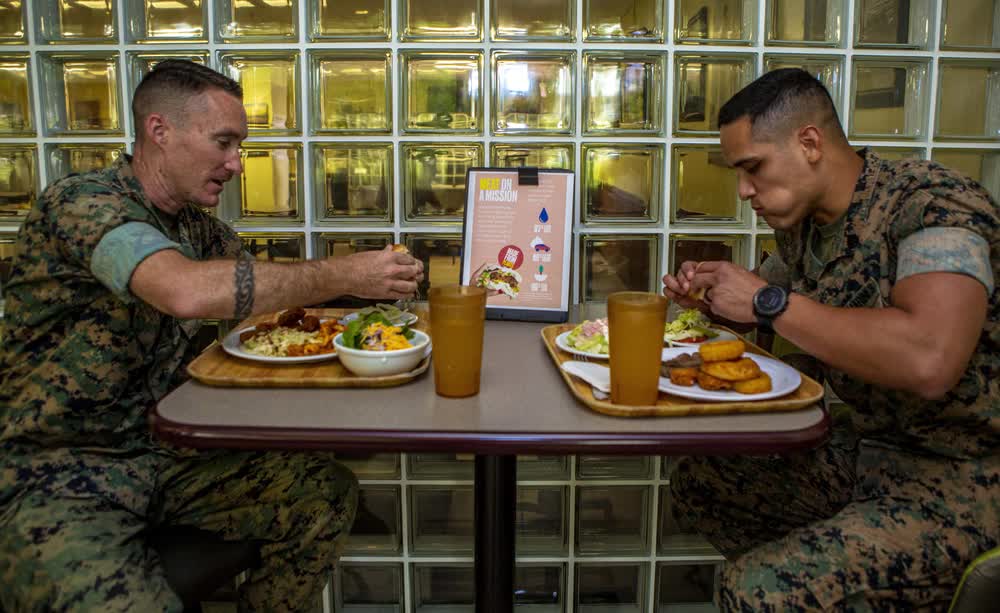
[{"xmin": 0, "ymin": 444, "xmax": 358, "ymax": 613}]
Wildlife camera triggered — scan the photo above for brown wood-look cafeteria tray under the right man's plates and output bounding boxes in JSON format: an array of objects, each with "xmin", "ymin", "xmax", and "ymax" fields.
[{"xmin": 542, "ymin": 323, "xmax": 823, "ymax": 417}]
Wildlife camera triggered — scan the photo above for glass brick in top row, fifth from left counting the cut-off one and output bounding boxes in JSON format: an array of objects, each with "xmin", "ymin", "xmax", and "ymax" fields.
[{"xmin": 308, "ymin": 0, "xmax": 392, "ymax": 41}]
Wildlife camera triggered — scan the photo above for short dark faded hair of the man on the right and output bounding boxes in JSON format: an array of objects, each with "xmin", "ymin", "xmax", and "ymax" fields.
[{"xmin": 719, "ymin": 68, "xmax": 846, "ymax": 140}]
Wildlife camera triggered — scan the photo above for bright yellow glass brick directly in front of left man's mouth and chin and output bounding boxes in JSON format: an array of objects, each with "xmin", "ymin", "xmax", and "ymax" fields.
[{"xmin": 223, "ymin": 142, "xmax": 302, "ymax": 222}]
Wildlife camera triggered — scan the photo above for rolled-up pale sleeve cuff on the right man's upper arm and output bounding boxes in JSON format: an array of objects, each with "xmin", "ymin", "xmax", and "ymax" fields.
[{"xmin": 896, "ymin": 227, "xmax": 995, "ymax": 296}]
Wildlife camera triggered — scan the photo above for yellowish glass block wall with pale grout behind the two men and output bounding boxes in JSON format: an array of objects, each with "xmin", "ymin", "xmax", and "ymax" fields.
[{"xmin": 0, "ymin": 0, "xmax": 1000, "ymax": 612}]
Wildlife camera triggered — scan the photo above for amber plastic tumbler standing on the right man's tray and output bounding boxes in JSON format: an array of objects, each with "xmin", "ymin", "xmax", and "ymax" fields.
[{"xmin": 604, "ymin": 292, "xmax": 669, "ymax": 406}]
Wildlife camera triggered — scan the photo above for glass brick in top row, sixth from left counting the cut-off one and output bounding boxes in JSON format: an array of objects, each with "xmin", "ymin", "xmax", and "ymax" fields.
[{"xmin": 398, "ymin": 0, "xmax": 483, "ymax": 42}]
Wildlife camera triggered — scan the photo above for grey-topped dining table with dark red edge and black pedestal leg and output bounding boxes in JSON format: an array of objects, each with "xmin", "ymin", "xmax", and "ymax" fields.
[{"xmin": 150, "ymin": 320, "xmax": 830, "ymax": 613}]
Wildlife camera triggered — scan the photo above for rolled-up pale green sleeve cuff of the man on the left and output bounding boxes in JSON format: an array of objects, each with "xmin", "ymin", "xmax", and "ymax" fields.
[{"xmin": 90, "ymin": 221, "xmax": 180, "ymax": 302}]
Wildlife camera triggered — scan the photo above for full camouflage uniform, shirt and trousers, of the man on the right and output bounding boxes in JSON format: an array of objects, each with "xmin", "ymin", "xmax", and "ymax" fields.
[{"xmin": 671, "ymin": 151, "xmax": 1000, "ymax": 611}]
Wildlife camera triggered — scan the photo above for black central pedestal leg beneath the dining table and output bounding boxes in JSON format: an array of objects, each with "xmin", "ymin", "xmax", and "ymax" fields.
[{"xmin": 475, "ymin": 455, "xmax": 517, "ymax": 613}]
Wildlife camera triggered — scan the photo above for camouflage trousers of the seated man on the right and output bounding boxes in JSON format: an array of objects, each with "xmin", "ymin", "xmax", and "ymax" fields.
[{"xmin": 671, "ymin": 432, "xmax": 1000, "ymax": 612}]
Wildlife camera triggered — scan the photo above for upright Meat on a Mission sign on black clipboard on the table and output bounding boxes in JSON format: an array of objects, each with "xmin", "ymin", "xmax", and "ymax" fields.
[{"xmin": 461, "ymin": 168, "xmax": 574, "ymax": 322}]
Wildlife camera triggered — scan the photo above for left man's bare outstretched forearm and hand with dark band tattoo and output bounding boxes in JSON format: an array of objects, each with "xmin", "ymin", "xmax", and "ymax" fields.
[{"xmin": 129, "ymin": 249, "xmax": 423, "ymax": 319}]
